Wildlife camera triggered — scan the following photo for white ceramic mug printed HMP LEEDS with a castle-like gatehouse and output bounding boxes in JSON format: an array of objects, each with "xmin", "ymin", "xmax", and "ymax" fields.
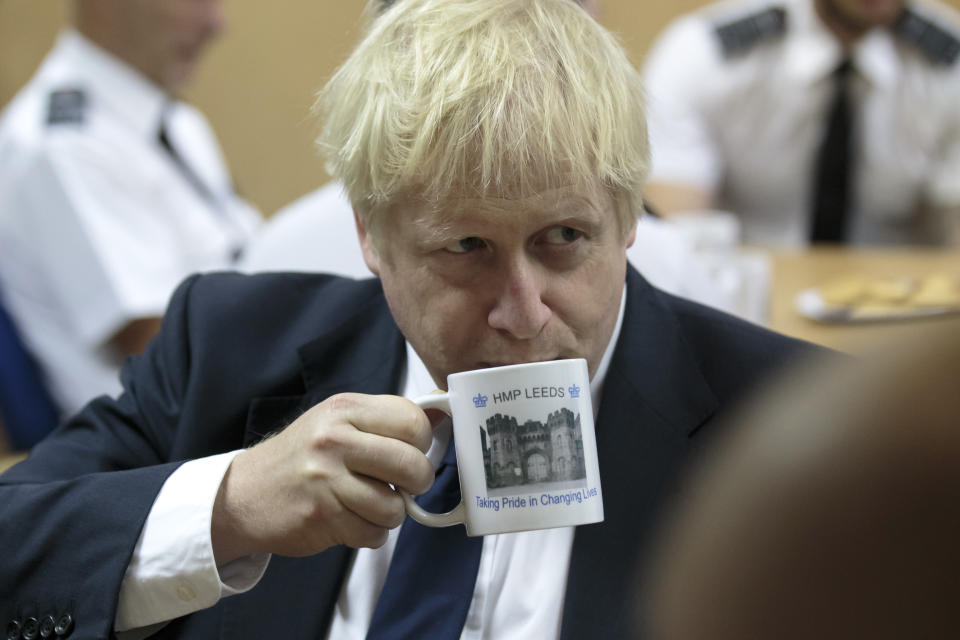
[{"xmin": 401, "ymin": 358, "xmax": 603, "ymax": 536}]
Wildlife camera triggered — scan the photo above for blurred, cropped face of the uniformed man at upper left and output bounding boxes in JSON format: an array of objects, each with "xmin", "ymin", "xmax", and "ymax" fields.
[{"xmin": 117, "ymin": 0, "xmax": 226, "ymax": 93}]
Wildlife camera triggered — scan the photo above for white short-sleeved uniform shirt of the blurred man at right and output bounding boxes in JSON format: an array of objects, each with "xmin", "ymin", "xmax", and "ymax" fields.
[{"xmin": 644, "ymin": 0, "xmax": 960, "ymax": 246}]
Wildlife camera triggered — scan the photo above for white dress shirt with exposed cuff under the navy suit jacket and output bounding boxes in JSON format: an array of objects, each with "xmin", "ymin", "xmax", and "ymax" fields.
[{"xmin": 115, "ymin": 288, "xmax": 626, "ymax": 640}]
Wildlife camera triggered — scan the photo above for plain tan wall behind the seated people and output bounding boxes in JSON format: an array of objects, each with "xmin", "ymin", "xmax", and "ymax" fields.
[{"xmin": 7, "ymin": 0, "xmax": 928, "ymax": 216}]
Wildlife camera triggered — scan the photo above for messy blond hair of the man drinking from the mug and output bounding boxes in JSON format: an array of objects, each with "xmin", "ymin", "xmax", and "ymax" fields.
[{"xmin": 315, "ymin": 0, "xmax": 649, "ymax": 231}]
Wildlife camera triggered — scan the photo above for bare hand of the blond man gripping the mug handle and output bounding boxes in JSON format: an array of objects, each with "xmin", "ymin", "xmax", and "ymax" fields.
[{"xmin": 211, "ymin": 394, "xmax": 433, "ymax": 566}]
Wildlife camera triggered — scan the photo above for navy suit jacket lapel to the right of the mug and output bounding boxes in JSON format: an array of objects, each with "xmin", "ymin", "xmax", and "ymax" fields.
[{"xmin": 561, "ymin": 268, "xmax": 717, "ymax": 638}]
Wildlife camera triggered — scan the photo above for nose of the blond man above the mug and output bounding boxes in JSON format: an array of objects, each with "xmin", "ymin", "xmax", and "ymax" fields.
[{"xmin": 487, "ymin": 261, "xmax": 553, "ymax": 340}]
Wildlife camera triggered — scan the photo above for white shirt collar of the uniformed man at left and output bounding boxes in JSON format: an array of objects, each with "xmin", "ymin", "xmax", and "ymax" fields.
[{"xmin": 55, "ymin": 29, "xmax": 170, "ymax": 138}]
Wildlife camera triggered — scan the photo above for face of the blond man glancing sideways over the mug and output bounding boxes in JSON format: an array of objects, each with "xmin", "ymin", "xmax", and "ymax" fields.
[{"xmin": 358, "ymin": 182, "xmax": 635, "ymax": 388}]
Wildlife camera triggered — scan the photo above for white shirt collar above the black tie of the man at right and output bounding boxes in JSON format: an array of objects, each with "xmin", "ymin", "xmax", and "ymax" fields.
[{"xmin": 785, "ymin": 0, "xmax": 900, "ymax": 87}]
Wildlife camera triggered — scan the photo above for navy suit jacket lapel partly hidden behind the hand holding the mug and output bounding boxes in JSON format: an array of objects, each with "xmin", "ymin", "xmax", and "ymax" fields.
[{"xmin": 227, "ymin": 288, "xmax": 405, "ymax": 638}]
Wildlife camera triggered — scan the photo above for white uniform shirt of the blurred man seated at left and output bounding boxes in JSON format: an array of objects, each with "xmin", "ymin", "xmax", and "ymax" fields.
[{"xmin": 0, "ymin": 31, "xmax": 260, "ymax": 414}]
